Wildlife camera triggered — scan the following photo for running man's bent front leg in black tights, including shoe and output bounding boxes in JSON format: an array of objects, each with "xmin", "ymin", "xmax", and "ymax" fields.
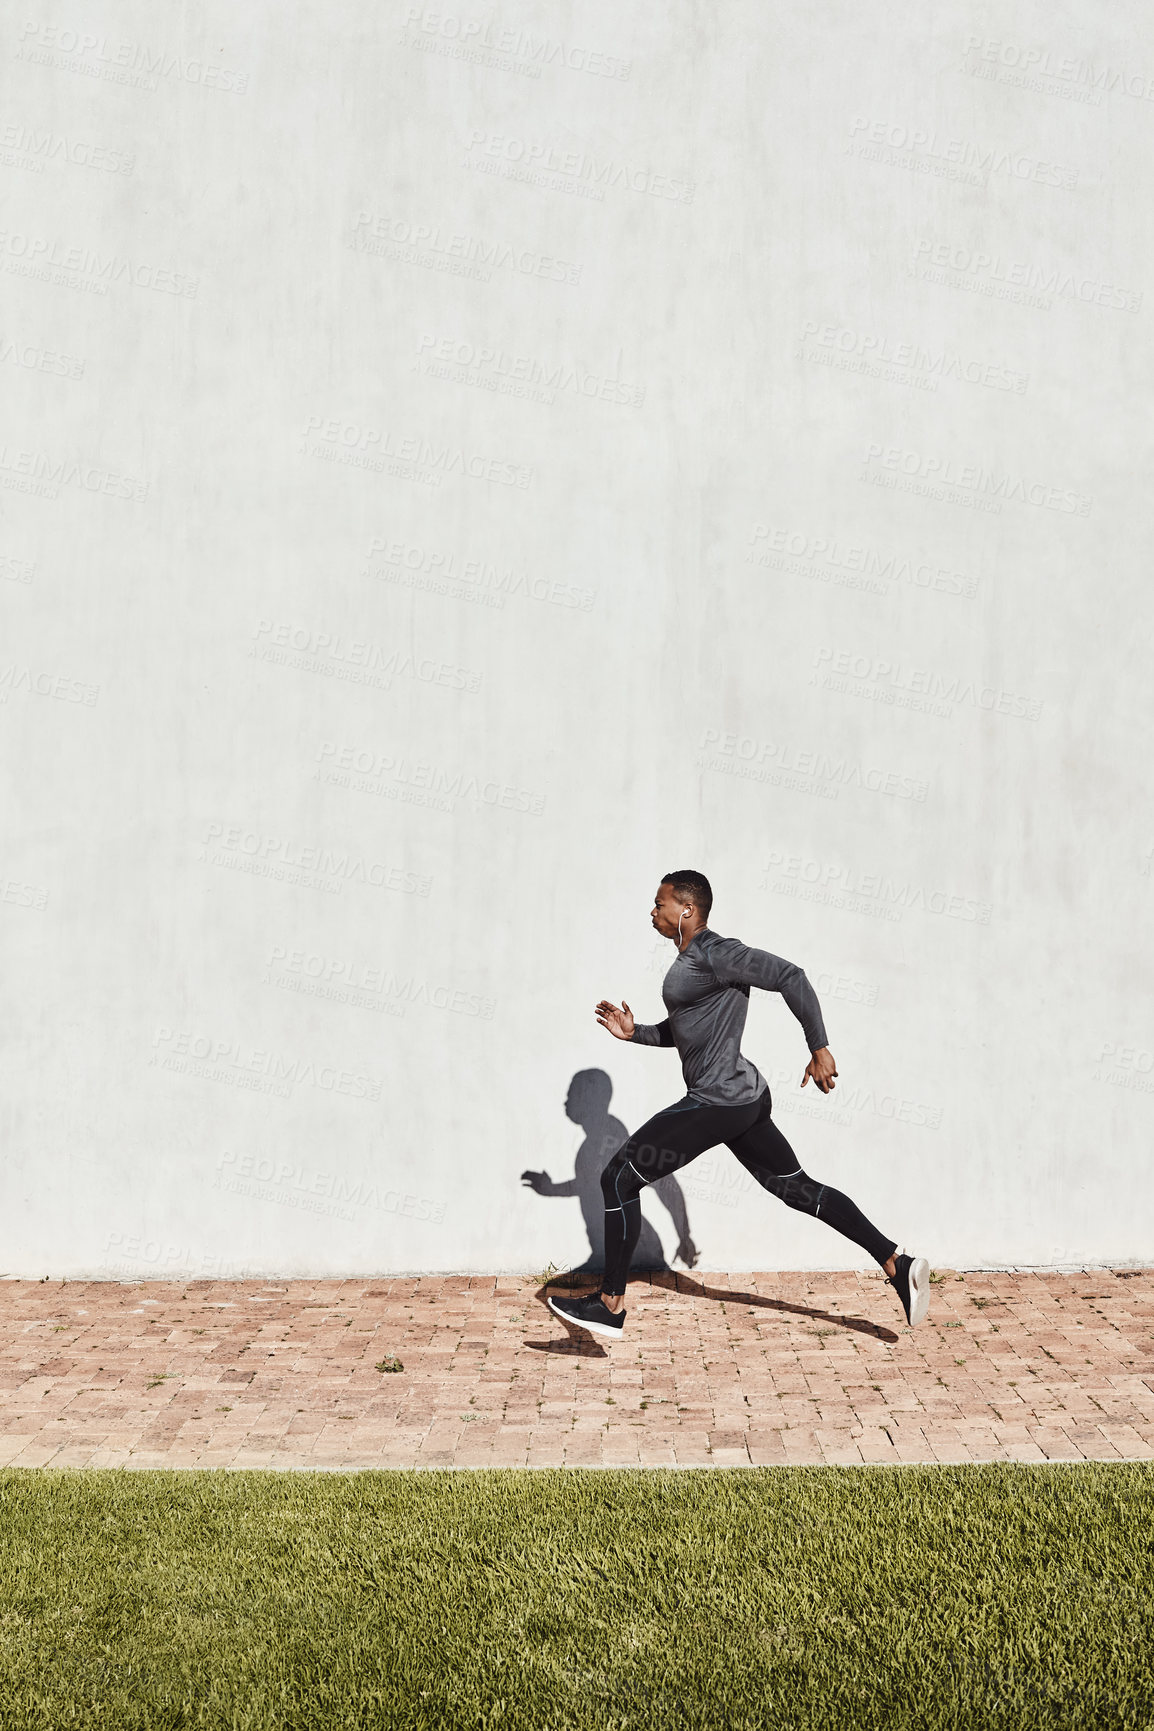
[{"xmin": 548, "ymin": 1094, "xmax": 760, "ymax": 1336}]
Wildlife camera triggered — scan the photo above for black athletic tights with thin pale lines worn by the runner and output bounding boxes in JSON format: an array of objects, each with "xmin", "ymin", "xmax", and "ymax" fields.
[{"xmin": 600, "ymin": 1087, "xmax": 898, "ymax": 1295}]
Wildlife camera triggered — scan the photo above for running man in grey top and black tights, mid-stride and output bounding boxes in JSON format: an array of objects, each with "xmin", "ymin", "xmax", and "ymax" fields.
[{"xmin": 548, "ymin": 871, "xmax": 929, "ymax": 1340}]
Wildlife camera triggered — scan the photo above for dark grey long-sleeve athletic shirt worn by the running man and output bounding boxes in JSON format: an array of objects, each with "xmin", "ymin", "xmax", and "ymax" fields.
[{"xmin": 633, "ymin": 926, "xmax": 829, "ymax": 1106}]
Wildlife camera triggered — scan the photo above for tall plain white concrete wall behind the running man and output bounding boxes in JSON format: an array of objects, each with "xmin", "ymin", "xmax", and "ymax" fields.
[{"xmin": 0, "ymin": 0, "xmax": 1154, "ymax": 1276}]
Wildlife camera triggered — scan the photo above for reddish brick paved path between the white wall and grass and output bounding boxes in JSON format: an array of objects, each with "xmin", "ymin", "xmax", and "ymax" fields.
[{"xmin": 0, "ymin": 1269, "xmax": 1154, "ymax": 1470}]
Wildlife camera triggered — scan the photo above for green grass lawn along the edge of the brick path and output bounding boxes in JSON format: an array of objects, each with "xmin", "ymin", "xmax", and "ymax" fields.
[{"xmin": 0, "ymin": 1463, "xmax": 1154, "ymax": 1731}]
